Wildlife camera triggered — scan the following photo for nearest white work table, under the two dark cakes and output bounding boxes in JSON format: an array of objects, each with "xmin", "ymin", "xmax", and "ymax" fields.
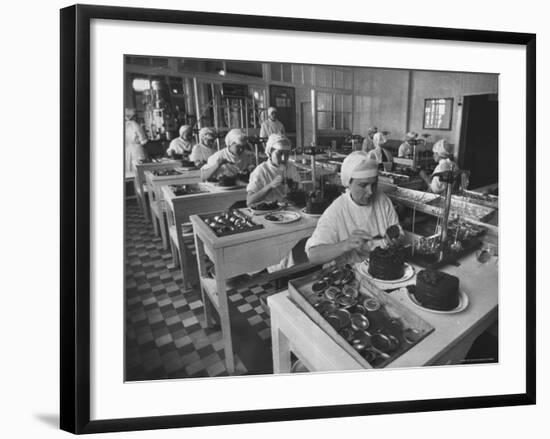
[{"xmin": 268, "ymin": 254, "xmax": 498, "ymax": 373}]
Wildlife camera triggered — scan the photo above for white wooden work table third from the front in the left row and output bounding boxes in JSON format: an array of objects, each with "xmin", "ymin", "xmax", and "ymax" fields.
[{"xmin": 161, "ymin": 183, "xmax": 246, "ymax": 292}]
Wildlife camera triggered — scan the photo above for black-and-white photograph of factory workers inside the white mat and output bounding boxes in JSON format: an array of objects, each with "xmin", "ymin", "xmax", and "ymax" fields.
[{"xmin": 124, "ymin": 56, "xmax": 502, "ymax": 382}]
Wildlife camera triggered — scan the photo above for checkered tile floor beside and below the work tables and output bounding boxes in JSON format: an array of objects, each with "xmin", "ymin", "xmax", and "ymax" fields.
[{"xmin": 125, "ymin": 200, "xmax": 276, "ymax": 381}]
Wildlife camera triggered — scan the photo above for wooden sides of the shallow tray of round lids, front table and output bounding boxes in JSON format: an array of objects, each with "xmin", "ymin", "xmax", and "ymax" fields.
[{"xmin": 288, "ymin": 270, "xmax": 434, "ymax": 369}]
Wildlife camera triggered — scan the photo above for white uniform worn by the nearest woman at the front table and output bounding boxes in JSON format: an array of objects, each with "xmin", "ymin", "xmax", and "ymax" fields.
[{"xmin": 306, "ymin": 190, "xmax": 401, "ymax": 264}]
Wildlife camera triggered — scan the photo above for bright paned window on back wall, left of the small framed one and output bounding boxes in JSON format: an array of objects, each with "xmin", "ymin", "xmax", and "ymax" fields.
[{"xmin": 317, "ymin": 92, "xmax": 352, "ymax": 130}]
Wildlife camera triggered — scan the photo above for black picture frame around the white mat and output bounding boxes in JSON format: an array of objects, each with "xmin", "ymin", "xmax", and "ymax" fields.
[{"xmin": 60, "ymin": 5, "xmax": 536, "ymax": 434}]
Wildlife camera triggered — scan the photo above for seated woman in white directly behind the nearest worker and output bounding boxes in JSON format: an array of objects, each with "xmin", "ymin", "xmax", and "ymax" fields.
[{"xmin": 246, "ymin": 134, "xmax": 291, "ymax": 206}]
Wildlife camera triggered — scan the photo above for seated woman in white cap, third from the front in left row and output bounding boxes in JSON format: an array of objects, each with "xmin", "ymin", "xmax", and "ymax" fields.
[{"xmin": 201, "ymin": 128, "xmax": 254, "ymax": 181}]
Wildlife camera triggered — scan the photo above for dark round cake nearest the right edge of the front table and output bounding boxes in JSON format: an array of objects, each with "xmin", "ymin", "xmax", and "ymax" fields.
[{"xmin": 413, "ymin": 269, "xmax": 459, "ymax": 311}]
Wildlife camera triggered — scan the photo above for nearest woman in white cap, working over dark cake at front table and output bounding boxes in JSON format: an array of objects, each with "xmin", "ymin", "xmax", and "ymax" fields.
[{"xmin": 306, "ymin": 151, "xmax": 403, "ymax": 265}]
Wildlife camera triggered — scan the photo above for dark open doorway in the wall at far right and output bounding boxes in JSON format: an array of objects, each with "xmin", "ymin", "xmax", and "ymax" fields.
[{"xmin": 458, "ymin": 94, "xmax": 498, "ymax": 189}]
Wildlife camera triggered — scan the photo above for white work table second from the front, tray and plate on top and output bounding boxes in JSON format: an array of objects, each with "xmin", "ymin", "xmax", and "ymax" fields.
[{"xmin": 191, "ymin": 208, "xmax": 318, "ymax": 373}]
